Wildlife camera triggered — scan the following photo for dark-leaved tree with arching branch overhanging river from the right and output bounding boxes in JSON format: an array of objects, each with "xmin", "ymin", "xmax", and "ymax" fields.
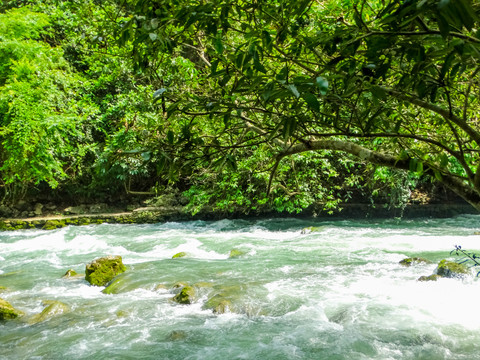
[{"xmin": 111, "ymin": 0, "xmax": 480, "ymax": 210}]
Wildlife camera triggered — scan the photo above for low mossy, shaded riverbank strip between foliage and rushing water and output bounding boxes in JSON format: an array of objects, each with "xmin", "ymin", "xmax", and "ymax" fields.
[{"xmin": 0, "ymin": 203, "xmax": 478, "ymax": 231}]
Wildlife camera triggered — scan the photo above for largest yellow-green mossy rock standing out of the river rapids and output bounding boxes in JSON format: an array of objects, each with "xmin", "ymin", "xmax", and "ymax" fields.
[{"xmin": 85, "ymin": 256, "xmax": 127, "ymax": 286}]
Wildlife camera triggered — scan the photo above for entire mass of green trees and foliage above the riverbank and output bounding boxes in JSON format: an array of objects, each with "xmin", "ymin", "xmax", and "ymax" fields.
[{"xmin": 0, "ymin": 0, "xmax": 480, "ymax": 213}]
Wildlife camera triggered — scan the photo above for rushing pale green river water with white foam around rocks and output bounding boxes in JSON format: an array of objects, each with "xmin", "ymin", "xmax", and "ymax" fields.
[{"xmin": 0, "ymin": 215, "xmax": 480, "ymax": 360}]
